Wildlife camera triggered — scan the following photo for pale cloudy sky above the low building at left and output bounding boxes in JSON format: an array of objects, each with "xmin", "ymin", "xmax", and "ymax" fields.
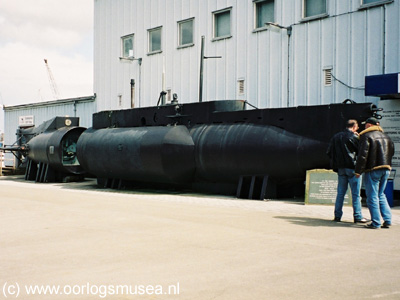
[{"xmin": 0, "ymin": 0, "xmax": 93, "ymax": 132}]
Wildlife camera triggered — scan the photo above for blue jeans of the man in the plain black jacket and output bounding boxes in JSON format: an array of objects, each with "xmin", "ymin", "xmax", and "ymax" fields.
[{"xmin": 335, "ymin": 168, "xmax": 363, "ymax": 220}]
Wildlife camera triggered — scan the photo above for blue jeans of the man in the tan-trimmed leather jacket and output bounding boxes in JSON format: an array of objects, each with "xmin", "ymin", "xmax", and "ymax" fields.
[{"xmin": 364, "ymin": 169, "xmax": 392, "ymax": 227}]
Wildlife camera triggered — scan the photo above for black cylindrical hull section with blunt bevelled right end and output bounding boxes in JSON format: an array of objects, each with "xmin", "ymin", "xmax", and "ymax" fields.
[{"xmin": 77, "ymin": 126, "xmax": 195, "ymax": 184}]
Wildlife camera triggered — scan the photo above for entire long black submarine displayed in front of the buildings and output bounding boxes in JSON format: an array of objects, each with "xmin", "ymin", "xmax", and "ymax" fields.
[{"xmin": 4, "ymin": 99, "xmax": 379, "ymax": 199}]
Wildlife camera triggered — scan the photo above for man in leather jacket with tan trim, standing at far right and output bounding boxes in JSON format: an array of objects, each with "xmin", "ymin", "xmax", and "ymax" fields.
[{"xmin": 355, "ymin": 118, "xmax": 394, "ymax": 229}]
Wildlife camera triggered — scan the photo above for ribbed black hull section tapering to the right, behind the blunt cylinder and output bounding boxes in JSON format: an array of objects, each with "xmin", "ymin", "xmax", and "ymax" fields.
[{"xmin": 190, "ymin": 124, "xmax": 329, "ymax": 183}]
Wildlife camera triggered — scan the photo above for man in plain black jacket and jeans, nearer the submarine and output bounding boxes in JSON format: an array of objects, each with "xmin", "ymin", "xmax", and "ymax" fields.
[{"xmin": 327, "ymin": 120, "xmax": 367, "ymax": 223}]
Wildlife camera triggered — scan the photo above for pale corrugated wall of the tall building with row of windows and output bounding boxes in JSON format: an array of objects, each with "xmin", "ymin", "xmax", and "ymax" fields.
[{"xmin": 94, "ymin": 0, "xmax": 400, "ymax": 111}]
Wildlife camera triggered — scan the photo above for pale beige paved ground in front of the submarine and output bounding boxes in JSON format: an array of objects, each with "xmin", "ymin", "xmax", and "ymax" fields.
[{"xmin": 0, "ymin": 176, "xmax": 400, "ymax": 299}]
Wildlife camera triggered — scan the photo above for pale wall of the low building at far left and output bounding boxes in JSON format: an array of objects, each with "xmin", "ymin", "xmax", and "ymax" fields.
[{"xmin": 4, "ymin": 96, "xmax": 96, "ymax": 166}]
